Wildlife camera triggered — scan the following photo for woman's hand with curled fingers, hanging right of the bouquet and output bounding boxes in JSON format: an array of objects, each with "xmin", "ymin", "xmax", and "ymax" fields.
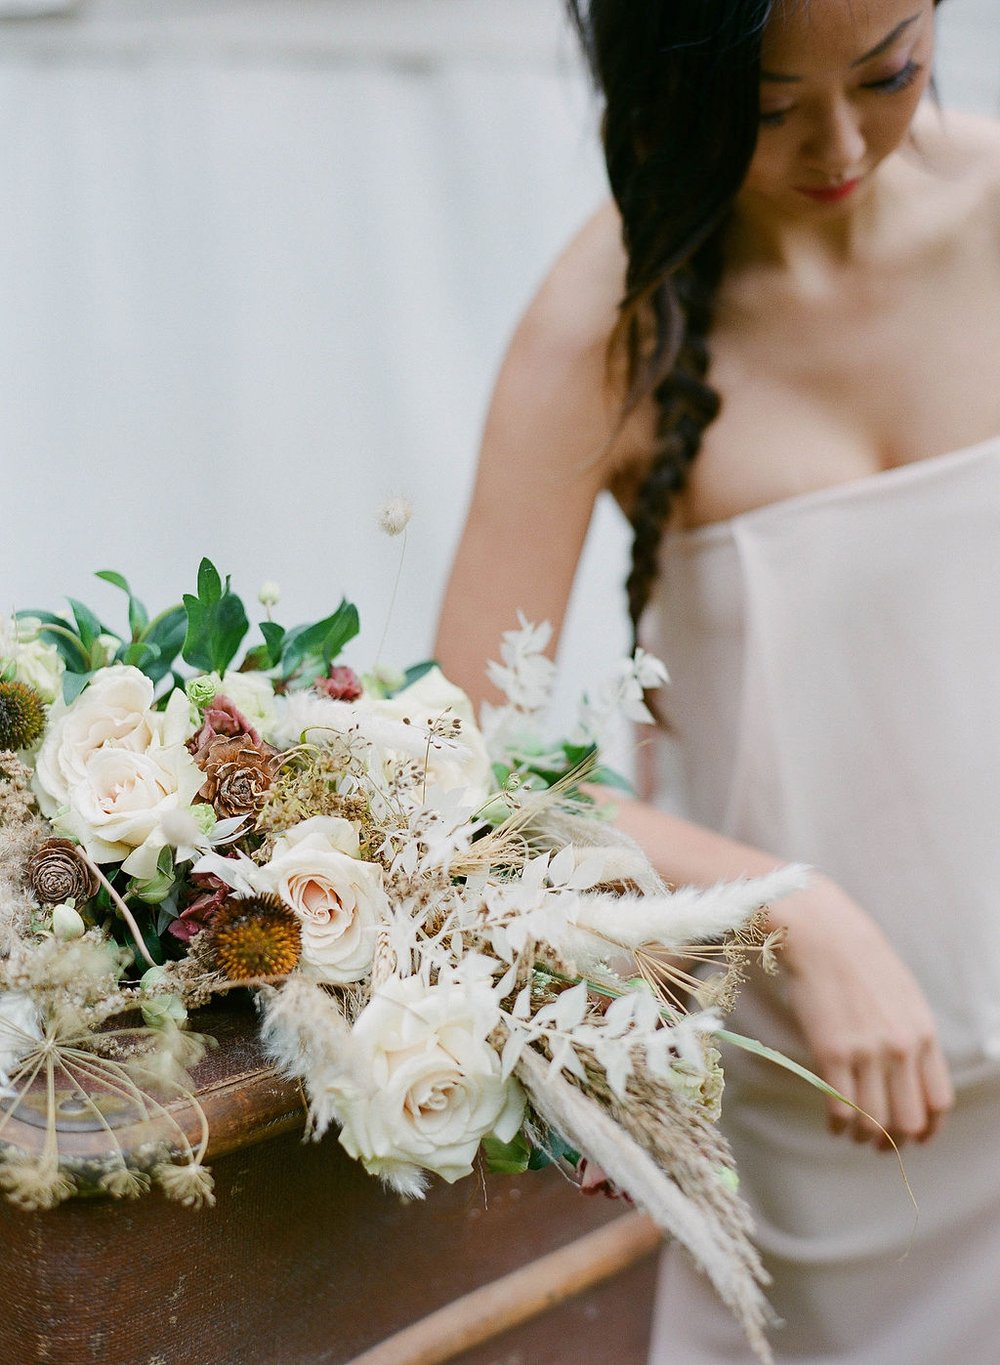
[{"xmin": 772, "ymin": 878, "xmax": 955, "ymax": 1149}]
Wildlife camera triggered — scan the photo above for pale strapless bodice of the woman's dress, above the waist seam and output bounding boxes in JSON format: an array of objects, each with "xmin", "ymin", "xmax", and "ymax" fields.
[{"xmin": 648, "ymin": 437, "xmax": 1000, "ymax": 1081}]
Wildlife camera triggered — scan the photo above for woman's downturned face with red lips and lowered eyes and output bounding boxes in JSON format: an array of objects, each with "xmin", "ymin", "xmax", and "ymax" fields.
[{"xmin": 741, "ymin": 0, "xmax": 935, "ymax": 216}]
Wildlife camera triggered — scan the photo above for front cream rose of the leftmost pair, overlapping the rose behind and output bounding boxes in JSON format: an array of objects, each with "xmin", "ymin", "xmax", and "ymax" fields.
[{"xmin": 57, "ymin": 744, "xmax": 205, "ymax": 878}]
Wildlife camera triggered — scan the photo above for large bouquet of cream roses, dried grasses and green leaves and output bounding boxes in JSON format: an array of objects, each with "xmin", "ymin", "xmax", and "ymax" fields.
[{"xmin": 0, "ymin": 560, "xmax": 801, "ymax": 1358}]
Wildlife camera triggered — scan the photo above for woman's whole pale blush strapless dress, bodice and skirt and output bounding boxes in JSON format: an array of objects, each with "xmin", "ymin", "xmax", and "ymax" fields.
[{"xmin": 638, "ymin": 437, "xmax": 1000, "ymax": 1365}]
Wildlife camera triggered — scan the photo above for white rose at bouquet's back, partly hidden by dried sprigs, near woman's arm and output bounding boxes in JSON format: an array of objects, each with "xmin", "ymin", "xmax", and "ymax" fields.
[{"xmin": 363, "ymin": 667, "xmax": 495, "ymax": 805}]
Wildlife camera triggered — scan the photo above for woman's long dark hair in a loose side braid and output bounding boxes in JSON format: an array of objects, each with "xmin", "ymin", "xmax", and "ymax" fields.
[{"xmin": 566, "ymin": 0, "xmax": 938, "ymax": 649}]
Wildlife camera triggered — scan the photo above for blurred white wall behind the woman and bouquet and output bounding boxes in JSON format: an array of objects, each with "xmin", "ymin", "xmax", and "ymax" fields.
[{"xmin": 0, "ymin": 0, "xmax": 1000, "ymax": 748}]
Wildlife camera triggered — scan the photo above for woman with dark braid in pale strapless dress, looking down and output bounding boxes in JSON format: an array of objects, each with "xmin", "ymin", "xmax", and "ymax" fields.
[{"xmin": 438, "ymin": 0, "xmax": 1000, "ymax": 1365}]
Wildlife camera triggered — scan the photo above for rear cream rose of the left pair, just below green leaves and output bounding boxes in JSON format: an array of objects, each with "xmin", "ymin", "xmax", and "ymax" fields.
[{"xmin": 34, "ymin": 663, "xmax": 191, "ymax": 815}]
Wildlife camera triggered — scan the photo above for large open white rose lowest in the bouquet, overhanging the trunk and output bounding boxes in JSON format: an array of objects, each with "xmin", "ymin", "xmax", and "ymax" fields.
[{"xmin": 330, "ymin": 976, "xmax": 524, "ymax": 1183}]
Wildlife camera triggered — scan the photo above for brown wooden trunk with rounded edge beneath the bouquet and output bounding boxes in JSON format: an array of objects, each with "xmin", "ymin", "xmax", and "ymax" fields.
[{"xmin": 0, "ymin": 1005, "xmax": 658, "ymax": 1365}]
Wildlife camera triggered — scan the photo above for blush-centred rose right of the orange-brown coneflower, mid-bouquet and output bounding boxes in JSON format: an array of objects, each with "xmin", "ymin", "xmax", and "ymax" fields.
[{"xmin": 256, "ymin": 815, "xmax": 389, "ymax": 986}]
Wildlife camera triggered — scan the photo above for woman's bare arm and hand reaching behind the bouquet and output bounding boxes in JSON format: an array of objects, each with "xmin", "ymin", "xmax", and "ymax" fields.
[{"xmin": 435, "ymin": 210, "xmax": 952, "ymax": 1144}]
